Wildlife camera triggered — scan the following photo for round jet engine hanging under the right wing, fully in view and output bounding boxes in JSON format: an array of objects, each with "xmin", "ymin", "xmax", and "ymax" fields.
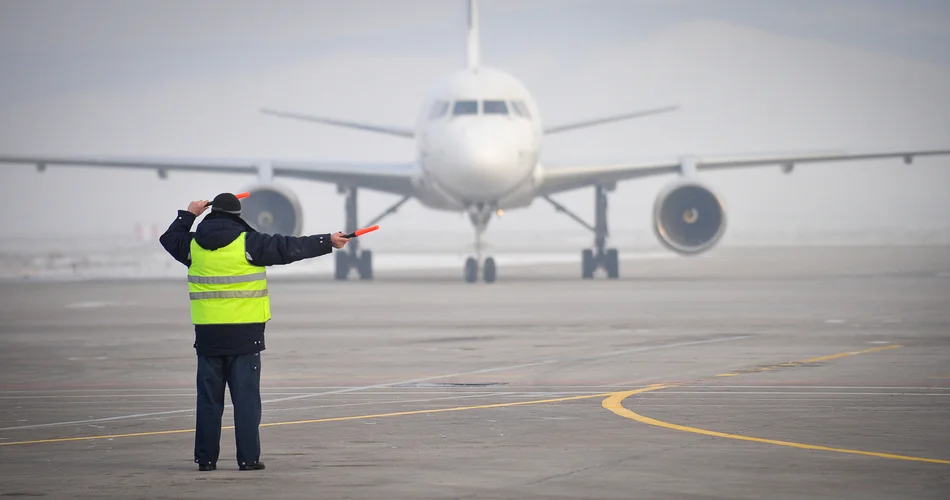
[{"xmin": 653, "ymin": 181, "xmax": 726, "ymax": 255}]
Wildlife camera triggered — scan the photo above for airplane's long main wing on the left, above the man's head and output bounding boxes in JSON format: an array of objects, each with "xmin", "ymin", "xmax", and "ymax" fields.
[{"xmin": 0, "ymin": 155, "xmax": 416, "ymax": 196}]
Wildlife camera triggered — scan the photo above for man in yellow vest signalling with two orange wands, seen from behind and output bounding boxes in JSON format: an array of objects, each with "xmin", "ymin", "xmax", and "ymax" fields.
[{"xmin": 159, "ymin": 193, "xmax": 349, "ymax": 471}]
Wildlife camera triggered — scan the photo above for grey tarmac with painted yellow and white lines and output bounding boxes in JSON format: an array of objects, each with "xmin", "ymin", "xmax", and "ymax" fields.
[{"xmin": 0, "ymin": 247, "xmax": 950, "ymax": 500}]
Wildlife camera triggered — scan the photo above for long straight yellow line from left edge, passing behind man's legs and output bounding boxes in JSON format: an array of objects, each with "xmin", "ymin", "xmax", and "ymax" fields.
[{"xmin": 0, "ymin": 388, "xmax": 632, "ymax": 446}]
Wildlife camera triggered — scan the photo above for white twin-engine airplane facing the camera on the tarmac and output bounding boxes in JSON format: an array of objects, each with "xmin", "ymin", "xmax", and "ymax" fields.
[{"xmin": 0, "ymin": 0, "xmax": 950, "ymax": 283}]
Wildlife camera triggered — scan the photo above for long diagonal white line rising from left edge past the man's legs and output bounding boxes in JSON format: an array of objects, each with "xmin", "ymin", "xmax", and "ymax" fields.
[{"xmin": 0, "ymin": 335, "xmax": 753, "ymax": 431}]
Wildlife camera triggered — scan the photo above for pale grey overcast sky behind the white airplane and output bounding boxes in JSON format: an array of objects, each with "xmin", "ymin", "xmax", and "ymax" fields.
[{"xmin": 0, "ymin": 0, "xmax": 950, "ymax": 242}]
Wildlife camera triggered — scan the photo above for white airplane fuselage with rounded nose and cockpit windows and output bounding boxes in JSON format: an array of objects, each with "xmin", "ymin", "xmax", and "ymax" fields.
[{"xmin": 415, "ymin": 67, "xmax": 542, "ymax": 210}]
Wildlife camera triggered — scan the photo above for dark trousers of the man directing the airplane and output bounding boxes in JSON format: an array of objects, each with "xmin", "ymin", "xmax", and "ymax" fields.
[{"xmin": 195, "ymin": 353, "xmax": 261, "ymax": 465}]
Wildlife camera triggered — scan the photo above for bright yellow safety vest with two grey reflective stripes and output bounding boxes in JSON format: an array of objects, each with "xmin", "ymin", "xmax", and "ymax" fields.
[{"xmin": 188, "ymin": 233, "xmax": 271, "ymax": 325}]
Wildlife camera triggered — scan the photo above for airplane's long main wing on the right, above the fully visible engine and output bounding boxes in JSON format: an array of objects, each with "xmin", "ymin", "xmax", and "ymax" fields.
[{"xmin": 540, "ymin": 149, "xmax": 950, "ymax": 195}]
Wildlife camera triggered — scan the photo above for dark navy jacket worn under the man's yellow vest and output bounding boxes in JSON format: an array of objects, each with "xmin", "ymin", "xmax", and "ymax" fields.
[{"xmin": 159, "ymin": 210, "xmax": 333, "ymax": 356}]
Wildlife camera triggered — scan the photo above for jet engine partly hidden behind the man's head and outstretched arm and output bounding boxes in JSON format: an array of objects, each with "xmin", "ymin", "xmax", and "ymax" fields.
[{"xmin": 241, "ymin": 184, "xmax": 303, "ymax": 236}]
